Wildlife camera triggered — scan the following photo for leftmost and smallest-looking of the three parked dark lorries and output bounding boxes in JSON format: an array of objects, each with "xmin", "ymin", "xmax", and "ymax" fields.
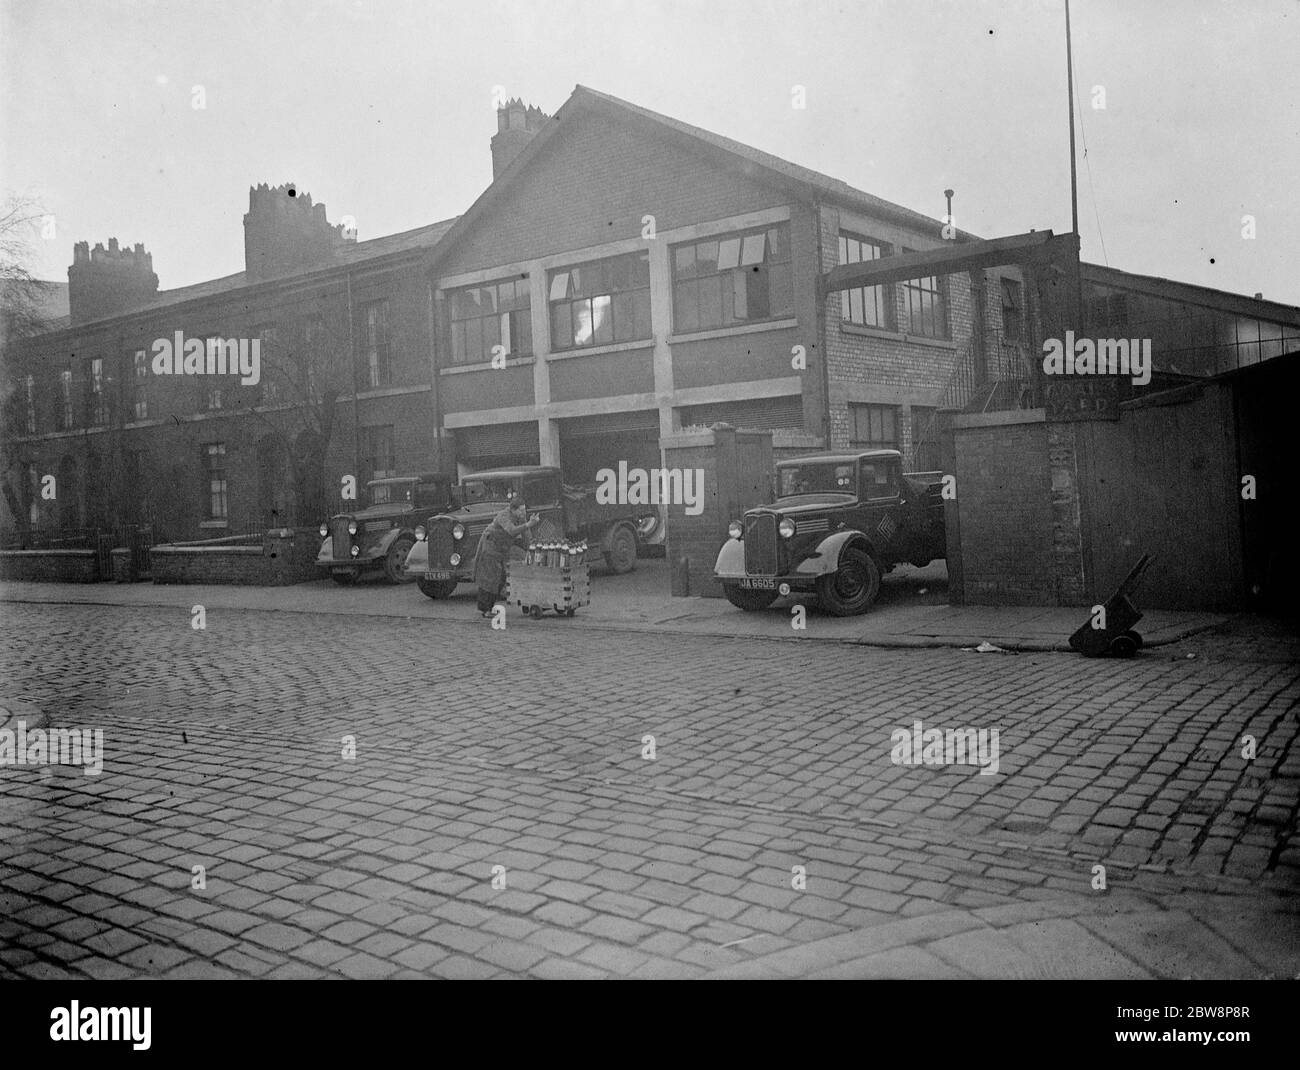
[{"xmin": 316, "ymin": 473, "xmax": 456, "ymax": 584}]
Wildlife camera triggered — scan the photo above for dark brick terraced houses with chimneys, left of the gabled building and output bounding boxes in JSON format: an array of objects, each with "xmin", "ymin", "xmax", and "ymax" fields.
[{"xmin": 4, "ymin": 185, "xmax": 451, "ymax": 540}]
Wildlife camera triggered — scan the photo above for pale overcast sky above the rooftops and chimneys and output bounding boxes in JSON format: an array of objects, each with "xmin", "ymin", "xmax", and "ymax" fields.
[{"xmin": 0, "ymin": 0, "xmax": 1300, "ymax": 304}]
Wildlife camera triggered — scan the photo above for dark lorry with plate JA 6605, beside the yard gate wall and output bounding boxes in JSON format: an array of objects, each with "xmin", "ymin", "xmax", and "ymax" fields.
[{"xmin": 714, "ymin": 450, "xmax": 945, "ymax": 616}]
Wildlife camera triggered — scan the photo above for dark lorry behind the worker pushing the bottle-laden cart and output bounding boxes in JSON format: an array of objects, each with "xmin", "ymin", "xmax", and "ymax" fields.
[{"xmin": 404, "ymin": 465, "xmax": 658, "ymax": 598}]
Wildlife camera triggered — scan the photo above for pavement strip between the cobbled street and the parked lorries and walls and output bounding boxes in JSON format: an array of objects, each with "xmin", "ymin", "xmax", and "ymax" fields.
[{"xmin": 0, "ymin": 559, "xmax": 1229, "ymax": 651}]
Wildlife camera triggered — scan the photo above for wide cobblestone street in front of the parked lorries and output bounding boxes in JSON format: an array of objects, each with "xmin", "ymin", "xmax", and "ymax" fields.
[{"xmin": 0, "ymin": 603, "xmax": 1300, "ymax": 978}]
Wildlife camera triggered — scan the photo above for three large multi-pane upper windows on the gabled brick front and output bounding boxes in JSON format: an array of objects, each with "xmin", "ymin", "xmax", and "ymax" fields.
[{"xmin": 449, "ymin": 224, "xmax": 794, "ymax": 364}]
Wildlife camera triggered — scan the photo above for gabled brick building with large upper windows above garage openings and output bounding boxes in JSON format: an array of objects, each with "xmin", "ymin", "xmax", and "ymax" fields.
[{"xmin": 429, "ymin": 87, "xmax": 1023, "ymax": 481}]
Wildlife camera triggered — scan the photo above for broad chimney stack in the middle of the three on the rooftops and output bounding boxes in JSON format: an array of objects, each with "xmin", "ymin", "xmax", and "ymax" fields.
[{"xmin": 244, "ymin": 182, "xmax": 346, "ymax": 281}]
